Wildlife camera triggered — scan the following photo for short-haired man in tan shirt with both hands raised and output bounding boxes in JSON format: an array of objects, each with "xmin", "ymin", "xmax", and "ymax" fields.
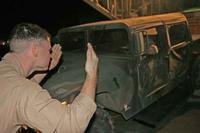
[{"xmin": 0, "ymin": 23, "xmax": 98, "ymax": 133}]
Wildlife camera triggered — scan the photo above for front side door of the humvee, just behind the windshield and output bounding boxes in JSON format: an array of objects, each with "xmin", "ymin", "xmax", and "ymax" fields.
[{"xmin": 139, "ymin": 26, "xmax": 168, "ymax": 97}]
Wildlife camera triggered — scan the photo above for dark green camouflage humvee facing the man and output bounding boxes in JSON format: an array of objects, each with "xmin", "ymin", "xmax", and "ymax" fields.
[{"xmin": 43, "ymin": 12, "xmax": 192, "ymax": 132}]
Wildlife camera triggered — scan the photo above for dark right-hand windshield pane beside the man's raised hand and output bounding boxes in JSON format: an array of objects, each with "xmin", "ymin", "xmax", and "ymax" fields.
[{"xmin": 90, "ymin": 29, "xmax": 129, "ymax": 55}]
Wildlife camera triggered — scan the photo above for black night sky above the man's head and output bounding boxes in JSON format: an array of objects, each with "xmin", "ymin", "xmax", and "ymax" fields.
[{"xmin": 0, "ymin": 0, "xmax": 108, "ymax": 40}]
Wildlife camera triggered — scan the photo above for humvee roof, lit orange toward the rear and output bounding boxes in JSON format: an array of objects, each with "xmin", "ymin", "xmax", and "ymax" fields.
[{"xmin": 67, "ymin": 12, "xmax": 186, "ymax": 29}]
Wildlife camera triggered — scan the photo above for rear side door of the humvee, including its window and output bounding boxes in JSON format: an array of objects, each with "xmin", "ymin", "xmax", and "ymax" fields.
[{"xmin": 167, "ymin": 22, "xmax": 191, "ymax": 80}]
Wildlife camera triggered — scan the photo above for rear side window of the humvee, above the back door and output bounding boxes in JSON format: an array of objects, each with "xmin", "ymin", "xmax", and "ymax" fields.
[{"xmin": 168, "ymin": 23, "xmax": 189, "ymax": 46}]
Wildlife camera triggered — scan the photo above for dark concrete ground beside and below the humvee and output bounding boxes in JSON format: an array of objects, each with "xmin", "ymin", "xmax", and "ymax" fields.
[{"xmin": 112, "ymin": 85, "xmax": 200, "ymax": 133}]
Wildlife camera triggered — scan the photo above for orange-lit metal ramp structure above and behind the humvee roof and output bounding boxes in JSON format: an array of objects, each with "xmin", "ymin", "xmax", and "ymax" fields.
[{"xmin": 83, "ymin": 0, "xmax": 182, "ymax": 19}]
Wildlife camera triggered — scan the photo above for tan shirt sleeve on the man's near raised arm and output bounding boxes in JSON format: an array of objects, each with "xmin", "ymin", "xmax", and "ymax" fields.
[{"xmin": 18, "ymin": 83, "xmax": 96, "ymax": 133}]
